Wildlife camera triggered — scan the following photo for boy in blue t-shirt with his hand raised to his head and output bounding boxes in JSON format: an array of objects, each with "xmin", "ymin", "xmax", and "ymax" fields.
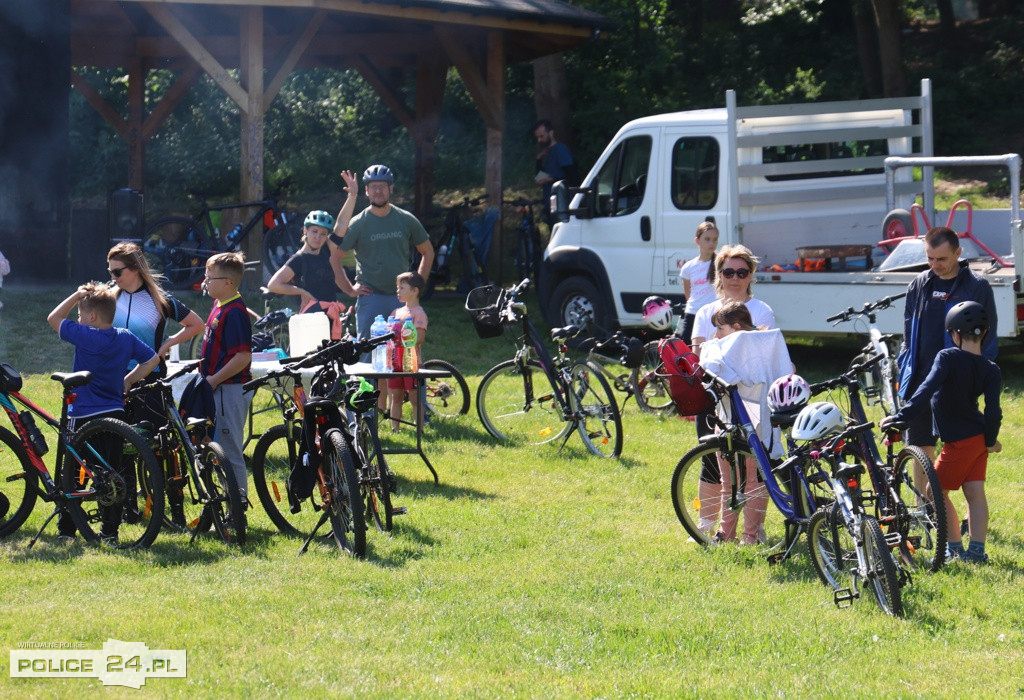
[{"xmin": 46, "ymin": 282, "xmax": 160, "ymax": 543}]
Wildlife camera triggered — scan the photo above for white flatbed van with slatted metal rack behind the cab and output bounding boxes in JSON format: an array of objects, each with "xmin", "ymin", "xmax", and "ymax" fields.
[{"xmin": 540, "ymin": 80, "xmax": 1024, "ymax": 337}]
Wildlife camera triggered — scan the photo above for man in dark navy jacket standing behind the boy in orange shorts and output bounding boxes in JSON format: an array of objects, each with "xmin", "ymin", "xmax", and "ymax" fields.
[{"xmin": 897, "ymin": 226, "xmax": 998, "ymax": 462}]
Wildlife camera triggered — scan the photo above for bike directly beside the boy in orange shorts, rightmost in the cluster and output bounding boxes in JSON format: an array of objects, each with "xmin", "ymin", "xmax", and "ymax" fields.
[{"xmin": 811, "ymin": 353, "xmax": 946, "ymax": 571}]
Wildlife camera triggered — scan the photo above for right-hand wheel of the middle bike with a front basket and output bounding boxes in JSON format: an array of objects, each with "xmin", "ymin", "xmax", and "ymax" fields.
[{"xmin": 569, "ymin": 361, "xmax": 623, "ymax": 457}]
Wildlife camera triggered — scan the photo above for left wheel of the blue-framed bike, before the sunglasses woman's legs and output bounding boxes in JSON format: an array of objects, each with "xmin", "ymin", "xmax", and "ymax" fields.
[{"xmin": 672, "ymin": 437, "xmax": 782, "ymax": 549}]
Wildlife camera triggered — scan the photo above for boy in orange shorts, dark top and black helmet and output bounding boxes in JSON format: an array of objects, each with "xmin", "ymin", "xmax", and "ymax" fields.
[{"xmin": 881, "ymin": 302, "xmax": 1002, "ymax": 564}]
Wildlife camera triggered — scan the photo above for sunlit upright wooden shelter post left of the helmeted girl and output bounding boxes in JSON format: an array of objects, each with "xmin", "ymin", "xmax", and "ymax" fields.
[{"xmin": 240, "ymin": 7, "xmax": 265, "ymax": 289}]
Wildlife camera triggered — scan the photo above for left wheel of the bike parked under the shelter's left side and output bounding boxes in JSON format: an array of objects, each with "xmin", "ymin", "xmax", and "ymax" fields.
[{"xmin": 142, "ymin": 216, "xmax": 212, "ymax": 290}]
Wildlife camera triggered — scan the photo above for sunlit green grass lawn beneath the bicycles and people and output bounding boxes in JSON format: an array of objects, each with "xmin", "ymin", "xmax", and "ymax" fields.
[{"xmin": 0, "ymin": 288, "xmax": 1024, "ymax": 698}]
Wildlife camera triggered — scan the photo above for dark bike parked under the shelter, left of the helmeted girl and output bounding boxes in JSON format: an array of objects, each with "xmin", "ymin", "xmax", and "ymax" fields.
[{"xmin": 142, "ymin": 179, "xmax": 302, "ymax": 289}]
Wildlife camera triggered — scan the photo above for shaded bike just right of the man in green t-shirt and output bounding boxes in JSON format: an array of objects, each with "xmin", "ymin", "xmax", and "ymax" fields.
[{"xmin": 420, "ymin": 196, "xmax": 498, "ymax": 301}]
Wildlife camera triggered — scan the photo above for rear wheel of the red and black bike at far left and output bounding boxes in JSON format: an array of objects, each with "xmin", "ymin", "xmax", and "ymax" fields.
[{"xmin": 60, "ymin": 418, "xmax": 164, "ymax": 550}]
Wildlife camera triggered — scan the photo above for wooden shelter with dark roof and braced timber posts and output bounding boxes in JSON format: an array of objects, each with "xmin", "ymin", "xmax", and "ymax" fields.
[{"xmin": 70, "ymin": 0, "xmax": 609, "ymax": 266}]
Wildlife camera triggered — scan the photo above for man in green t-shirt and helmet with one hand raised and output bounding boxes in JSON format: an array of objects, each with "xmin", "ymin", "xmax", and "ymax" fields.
[{"xmin": 331, "ymin": 165, "xmax": 434, "ymax": 338}]
